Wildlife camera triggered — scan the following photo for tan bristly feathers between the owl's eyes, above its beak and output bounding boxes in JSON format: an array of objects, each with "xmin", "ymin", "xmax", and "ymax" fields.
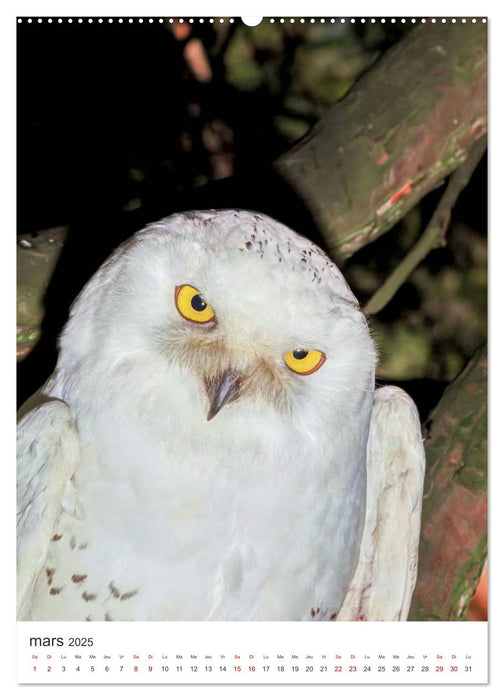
[{"xmin": 163, "ymin": 334, "xmax": 290, "ymax": 411}]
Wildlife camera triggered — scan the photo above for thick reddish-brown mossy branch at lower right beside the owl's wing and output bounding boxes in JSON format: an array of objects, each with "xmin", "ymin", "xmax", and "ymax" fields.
[{"xmin": 409, "ymin": 347, "xmax": 487, "ymax": 620}]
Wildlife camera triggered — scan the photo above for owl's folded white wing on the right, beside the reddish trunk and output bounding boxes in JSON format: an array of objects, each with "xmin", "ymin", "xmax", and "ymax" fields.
[{"xmin": 337, "ymin": 386, "xmax": 425, "ymax": 621}]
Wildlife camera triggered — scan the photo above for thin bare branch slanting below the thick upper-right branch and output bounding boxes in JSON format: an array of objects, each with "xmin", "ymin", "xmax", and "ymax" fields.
[{"xmin": 364, "ymin": 138, "xmax": 486, "ymax": 315}]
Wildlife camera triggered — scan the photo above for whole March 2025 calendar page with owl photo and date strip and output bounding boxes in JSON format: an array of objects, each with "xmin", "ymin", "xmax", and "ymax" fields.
[{"xmin": 12, "ymin": 4, "xmax": 488, "ymax": 686}]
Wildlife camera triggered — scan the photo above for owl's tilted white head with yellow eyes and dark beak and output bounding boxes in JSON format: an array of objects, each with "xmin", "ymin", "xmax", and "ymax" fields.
[{"xmin": 51, "ymin": 210, "xmax": 375, "ymax": 434}]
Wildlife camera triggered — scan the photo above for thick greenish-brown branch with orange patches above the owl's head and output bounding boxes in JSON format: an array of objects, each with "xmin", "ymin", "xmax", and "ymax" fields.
[{"xmin": 275, "ymin": 22, "xmax": 487, "ymax": 259}]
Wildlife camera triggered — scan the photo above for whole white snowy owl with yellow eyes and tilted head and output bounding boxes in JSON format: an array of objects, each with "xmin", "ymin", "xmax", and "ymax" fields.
[{"xmin": 18, "ymin": 210, "xmax": 424, "ymax": 621}]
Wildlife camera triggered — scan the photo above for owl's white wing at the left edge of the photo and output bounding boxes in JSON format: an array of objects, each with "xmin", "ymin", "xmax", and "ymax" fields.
[{"xmin": 17, "ymin": 399, "xmax": 80, "ymax": 619}]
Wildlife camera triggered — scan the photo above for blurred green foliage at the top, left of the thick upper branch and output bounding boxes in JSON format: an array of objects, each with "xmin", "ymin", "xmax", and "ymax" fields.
[{"xmin": 224, "ymin": 22, "xmax": 375, "ymax": 134}]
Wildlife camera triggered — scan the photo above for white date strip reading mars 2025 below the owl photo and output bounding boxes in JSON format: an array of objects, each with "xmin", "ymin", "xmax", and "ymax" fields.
[{"xmin": 18, "ymin": 622, "xmax": 488, "ymax": 684}]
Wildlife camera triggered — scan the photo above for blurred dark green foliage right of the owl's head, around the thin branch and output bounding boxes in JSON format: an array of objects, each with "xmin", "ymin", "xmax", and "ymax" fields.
[{"xmin": 344, "ymin": 191, "xmax": 487, "ymax": 382}]
